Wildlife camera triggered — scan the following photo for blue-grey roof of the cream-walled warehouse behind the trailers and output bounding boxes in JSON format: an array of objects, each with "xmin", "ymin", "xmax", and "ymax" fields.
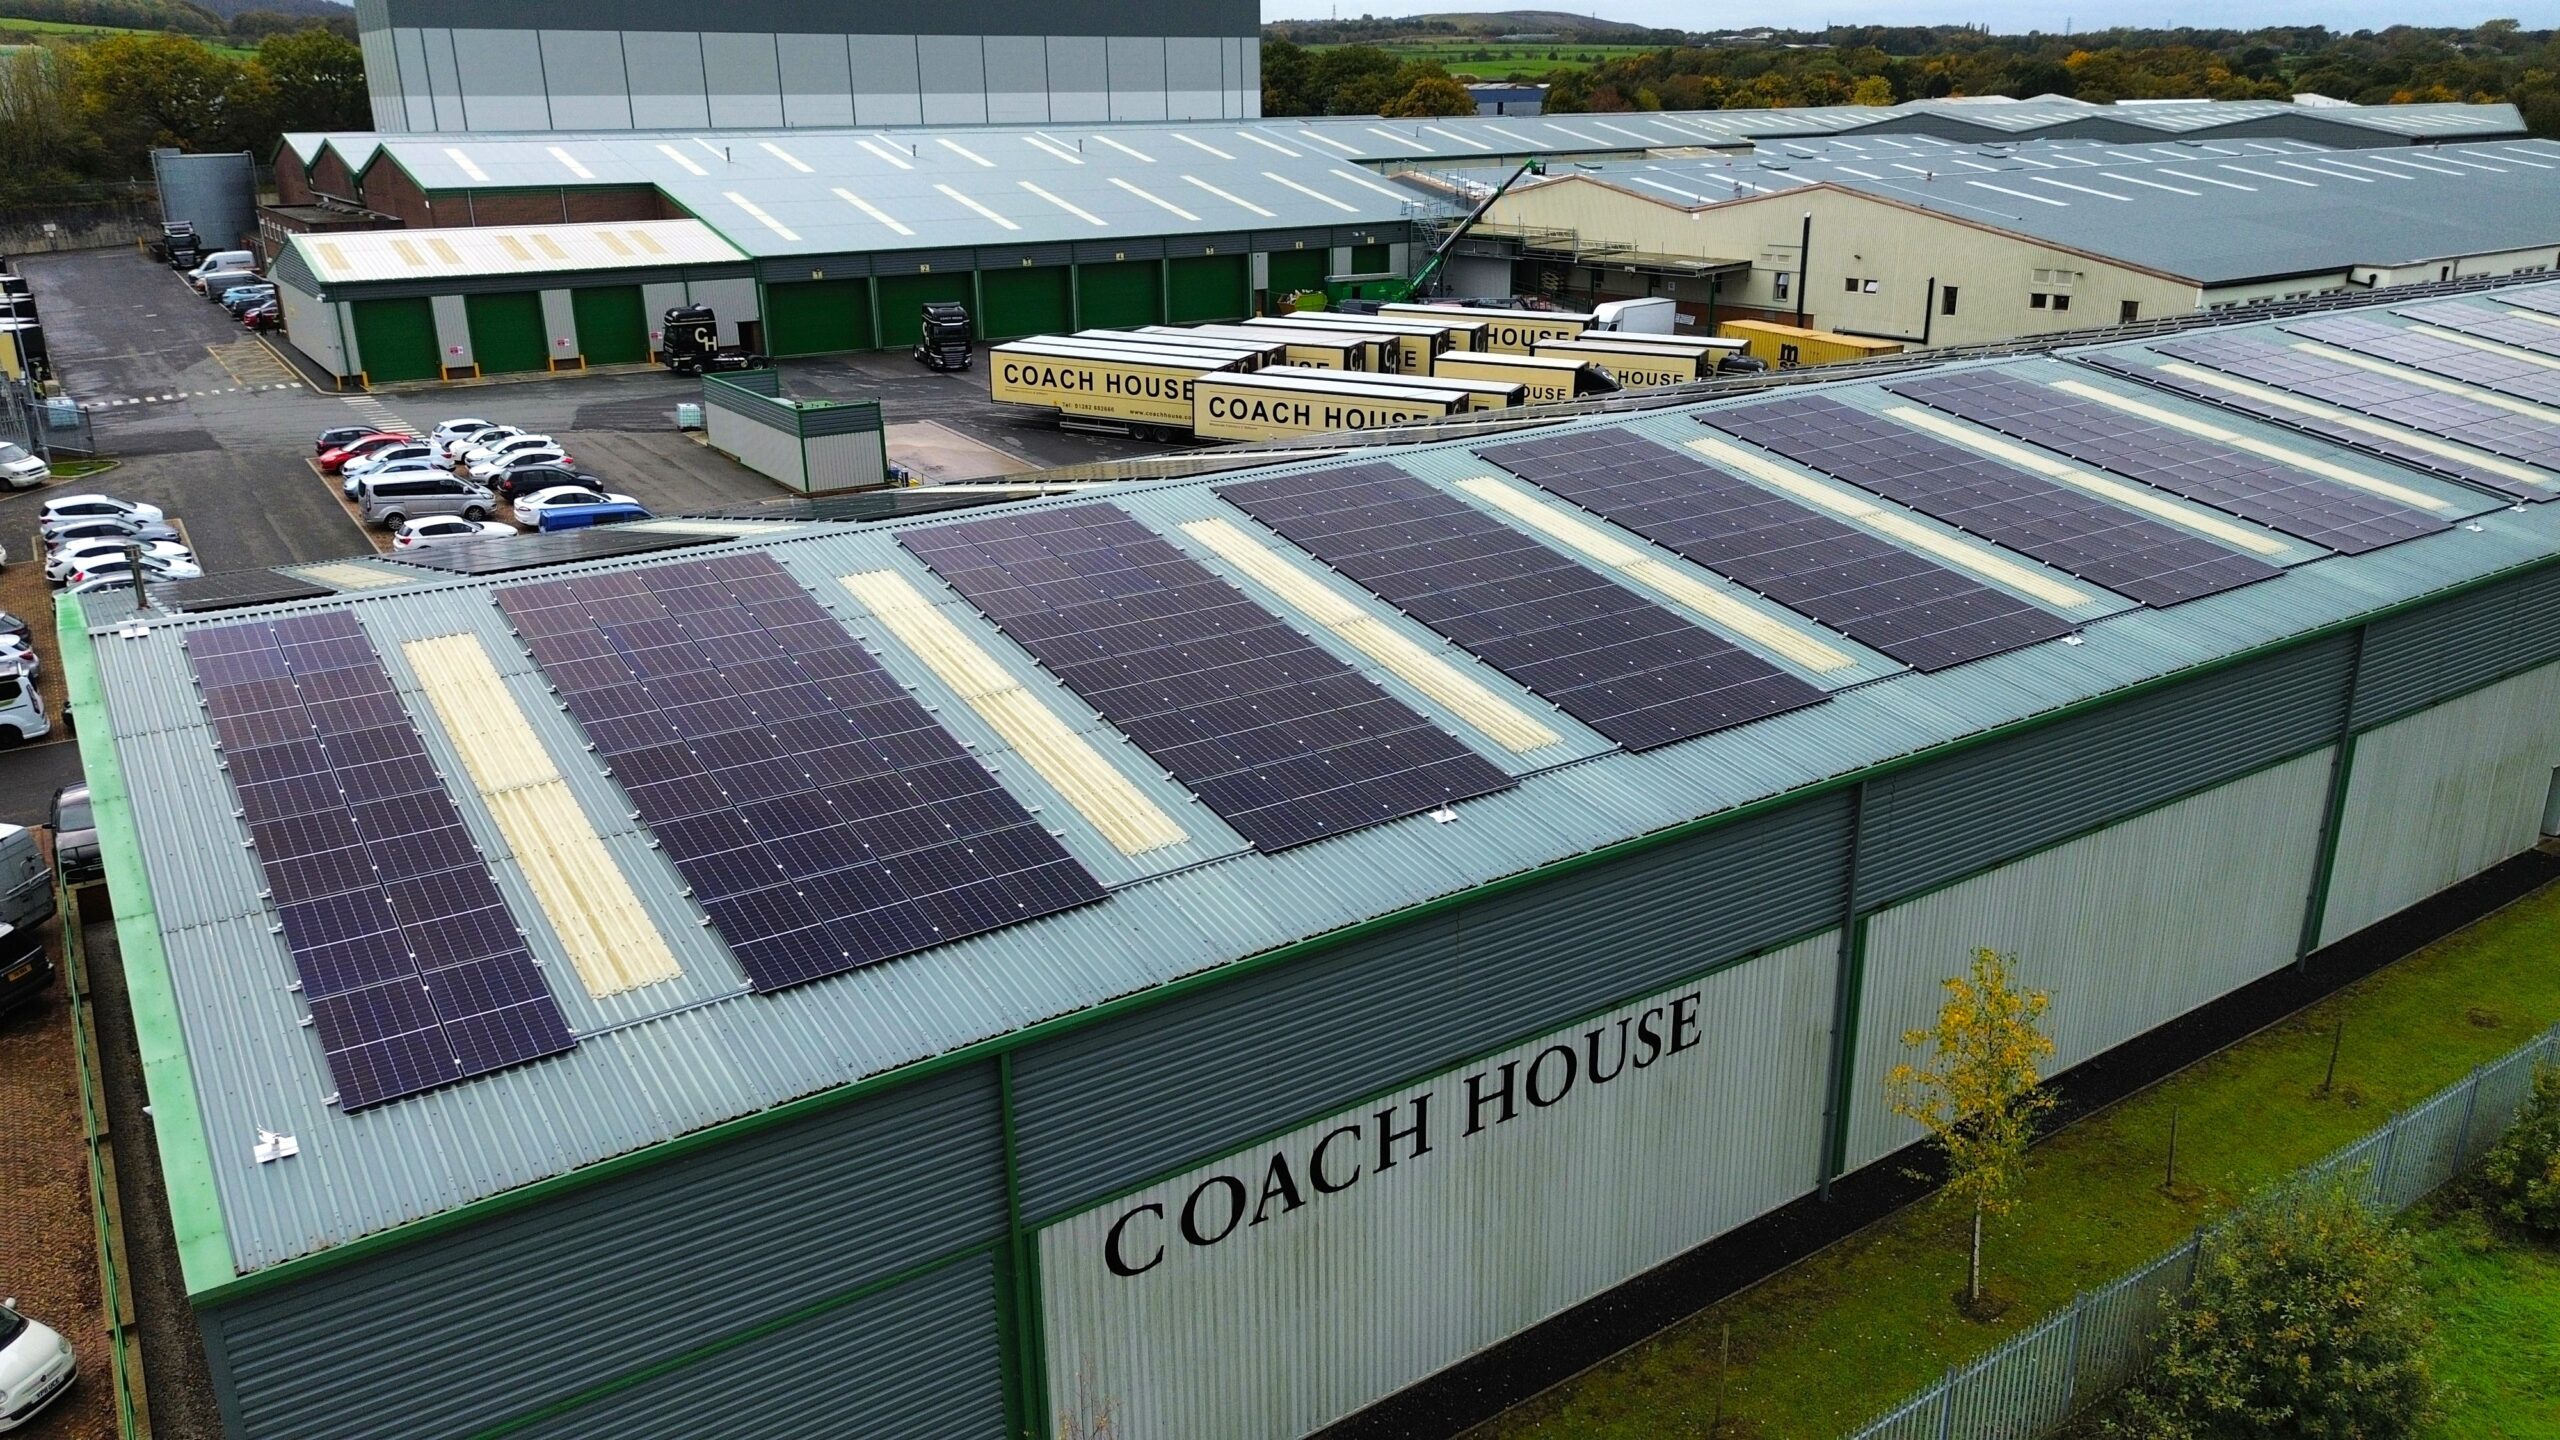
[{"xmin": 1515, "ymin": 136, "xmax": 2560, "ymax": 284}]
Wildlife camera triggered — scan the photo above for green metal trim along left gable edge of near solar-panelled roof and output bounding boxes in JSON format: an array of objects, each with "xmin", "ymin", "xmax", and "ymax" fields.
[{"xmin": 54, "ymin": 594, "xmax": 233, "ymax": 1294}]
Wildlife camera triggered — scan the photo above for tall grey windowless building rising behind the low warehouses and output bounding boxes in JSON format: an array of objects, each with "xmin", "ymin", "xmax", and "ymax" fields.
[{"xmin": 356, "ymin": 0, "xmax": 1262, "ymax": 131}]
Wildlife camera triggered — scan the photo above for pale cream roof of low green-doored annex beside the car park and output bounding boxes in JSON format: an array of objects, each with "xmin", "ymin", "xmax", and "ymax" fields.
[{"xmin": 287, "ymin": 220, "xmax": 748, "ymax": 284}]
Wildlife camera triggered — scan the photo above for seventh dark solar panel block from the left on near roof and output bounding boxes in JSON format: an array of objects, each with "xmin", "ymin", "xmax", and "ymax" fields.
[{"xmin": 1884, "ymin": 366, "xmax": 2437, "ymax": 556}]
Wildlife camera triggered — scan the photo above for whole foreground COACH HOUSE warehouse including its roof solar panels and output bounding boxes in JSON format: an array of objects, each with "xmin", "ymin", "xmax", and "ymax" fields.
[{"xmin": 64, "ymin": 274, "xmax": 2560, "ymax": 1440}]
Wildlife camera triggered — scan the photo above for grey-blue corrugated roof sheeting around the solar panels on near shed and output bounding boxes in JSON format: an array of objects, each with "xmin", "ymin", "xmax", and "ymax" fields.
[{"xmin": 90, "ymin": 285, "xmax": 2560, "ymax": 1273}]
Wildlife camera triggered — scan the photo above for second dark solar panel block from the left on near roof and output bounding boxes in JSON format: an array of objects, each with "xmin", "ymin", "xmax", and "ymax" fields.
[{"xmin": 497, "ymin": 553, "xmax": 1103, "ymax": 989}]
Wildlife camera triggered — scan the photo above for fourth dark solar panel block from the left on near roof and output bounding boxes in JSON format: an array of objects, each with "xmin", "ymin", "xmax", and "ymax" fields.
[{"xmin": 1219, "ymin": 464, "xmax": 1825, "ymax": 751}]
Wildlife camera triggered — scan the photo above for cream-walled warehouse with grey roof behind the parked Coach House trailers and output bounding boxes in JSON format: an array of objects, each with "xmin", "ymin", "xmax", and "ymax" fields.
[{"xmin": 1484, "ymin": 133, "xmax": 2560, "ymax": 346}]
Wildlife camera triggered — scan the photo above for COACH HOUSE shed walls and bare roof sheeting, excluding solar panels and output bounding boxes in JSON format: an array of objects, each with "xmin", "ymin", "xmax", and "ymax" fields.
[{"xmin": 64, "ymin": 290, "xmax": 2560, "ymax": 1440}]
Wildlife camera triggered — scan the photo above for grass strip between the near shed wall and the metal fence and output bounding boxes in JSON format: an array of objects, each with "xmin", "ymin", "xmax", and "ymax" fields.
[{"xmin": 1475, "ymin": 887, "xmax": 2560, "ymax": 1440}]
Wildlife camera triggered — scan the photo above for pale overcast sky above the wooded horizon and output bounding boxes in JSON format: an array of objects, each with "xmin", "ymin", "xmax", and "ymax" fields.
[{"xmin": 1262, "ymin": 0, "xmax": 2560, "ymax": 33}]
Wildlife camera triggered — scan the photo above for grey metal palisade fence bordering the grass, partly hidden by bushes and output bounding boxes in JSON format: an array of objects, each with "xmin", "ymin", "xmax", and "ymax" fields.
[{"xmin": 1848, "ymin": 1025, "xmax": 2560, "ymax": 1440}]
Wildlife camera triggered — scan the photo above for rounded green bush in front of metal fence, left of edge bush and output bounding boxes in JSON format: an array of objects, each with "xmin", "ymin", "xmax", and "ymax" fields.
[{"xmin": 2104, "ymin": 1181, "xmax": 2435, "ymax": 1440}]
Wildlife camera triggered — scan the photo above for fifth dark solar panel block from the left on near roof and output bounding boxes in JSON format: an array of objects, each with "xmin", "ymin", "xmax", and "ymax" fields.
[{"xmin": 1477, "ymin": 430, "xmax": 2071, "ymax": 671}]
